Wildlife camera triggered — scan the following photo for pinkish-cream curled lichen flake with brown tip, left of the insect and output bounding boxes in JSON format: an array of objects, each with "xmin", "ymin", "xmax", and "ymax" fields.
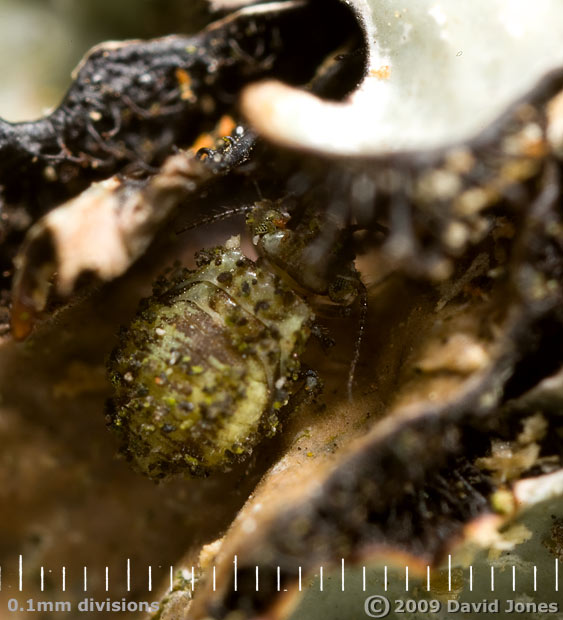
[{"xmin": 12, "ymin": 126, "xmax": 255, "ymax": 339}]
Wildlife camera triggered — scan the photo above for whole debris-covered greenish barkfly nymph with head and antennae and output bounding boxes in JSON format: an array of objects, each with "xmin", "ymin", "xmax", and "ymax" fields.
[{"xmin": 108, "ymin": 191, "xmax": 366, "ymax": 479}]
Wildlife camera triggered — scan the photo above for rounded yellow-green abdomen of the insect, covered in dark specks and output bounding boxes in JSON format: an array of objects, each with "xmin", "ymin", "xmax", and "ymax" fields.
[{"xmin": 109, "ymin": 238, "xmax": 313, "ymax": 479}]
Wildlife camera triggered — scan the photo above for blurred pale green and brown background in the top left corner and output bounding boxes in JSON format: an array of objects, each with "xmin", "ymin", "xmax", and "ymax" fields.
[{"xmin": 0, "ymin": 0, "xmax": 209, "ymax": 122}]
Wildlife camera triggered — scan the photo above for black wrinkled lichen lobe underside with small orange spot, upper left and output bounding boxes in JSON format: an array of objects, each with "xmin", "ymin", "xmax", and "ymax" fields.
[{"xmin": 0, "ymin": 1, "xmax": 366, "ymax": 222}]
